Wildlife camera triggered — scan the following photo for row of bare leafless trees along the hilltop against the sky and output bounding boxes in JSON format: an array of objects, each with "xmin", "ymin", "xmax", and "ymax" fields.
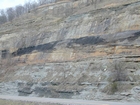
[{"xmin": 0, "ymin": 0, "xmax": 56, "ymax": 25}]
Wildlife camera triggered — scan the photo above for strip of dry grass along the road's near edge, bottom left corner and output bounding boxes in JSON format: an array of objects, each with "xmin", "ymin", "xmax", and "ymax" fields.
[{"xmin": 0, "ymin": 99, "xmax": 62, "ymax": 105}]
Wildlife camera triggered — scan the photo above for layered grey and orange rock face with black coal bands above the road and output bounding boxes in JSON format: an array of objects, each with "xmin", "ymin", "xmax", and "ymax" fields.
[{"xmin": 0, "ymin": 0, "xmax": 140, "ymax": 100}]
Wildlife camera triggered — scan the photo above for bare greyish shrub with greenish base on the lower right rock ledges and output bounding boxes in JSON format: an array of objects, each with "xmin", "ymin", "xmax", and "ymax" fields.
[{"xmin": 103, "ymin": 60, "xmax": 128, "ymax": 94}]
